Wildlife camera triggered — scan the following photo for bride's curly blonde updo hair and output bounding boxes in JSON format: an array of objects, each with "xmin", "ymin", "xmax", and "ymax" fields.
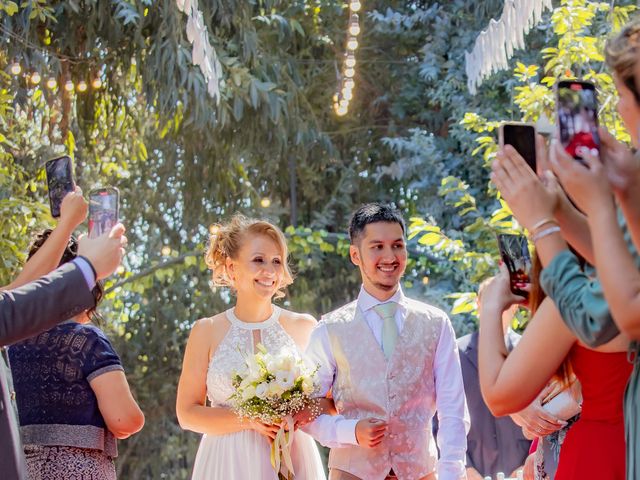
[{"xmin": 205, "ymin": 214, "xmax": 293, "ymax": 298}]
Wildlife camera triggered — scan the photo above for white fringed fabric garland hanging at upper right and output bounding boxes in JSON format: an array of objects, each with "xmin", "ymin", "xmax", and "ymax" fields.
[{"xmin": 462, "ymin": 0, "xmax": 553, "ymax": 95}]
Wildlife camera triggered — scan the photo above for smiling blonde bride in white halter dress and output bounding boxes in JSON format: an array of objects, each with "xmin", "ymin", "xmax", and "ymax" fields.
[{"xmin": 176, "ymin": 215, "xmax": 333, "ymax": 480}]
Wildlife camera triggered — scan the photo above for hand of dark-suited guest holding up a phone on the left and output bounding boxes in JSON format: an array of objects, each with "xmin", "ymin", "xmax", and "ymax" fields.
[{"xmin": 78, "ymin": 223, "xmax": 127, "ymax": 280}]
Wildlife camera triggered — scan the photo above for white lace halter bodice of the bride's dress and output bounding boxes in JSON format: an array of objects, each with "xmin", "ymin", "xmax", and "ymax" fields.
[{"xmin": 207, "ymin": 305, "xmax": 298, "ymax": 407}]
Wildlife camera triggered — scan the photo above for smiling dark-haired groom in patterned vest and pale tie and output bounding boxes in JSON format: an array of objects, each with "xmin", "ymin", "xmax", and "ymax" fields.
[{"xmin": 304, "ymin": 203, "xmax": 469, "ymax": 480}]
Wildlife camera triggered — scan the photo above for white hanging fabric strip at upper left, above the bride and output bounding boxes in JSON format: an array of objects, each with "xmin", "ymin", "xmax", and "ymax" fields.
[{"xmin": 176, "ymin": 0, "xmax": 222, "ymax": 103}]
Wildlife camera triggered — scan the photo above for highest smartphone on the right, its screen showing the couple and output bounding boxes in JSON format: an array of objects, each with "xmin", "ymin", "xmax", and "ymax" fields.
[{"xmin": 556, "ymin": 80, "xmax": 600, "ymax": 161}]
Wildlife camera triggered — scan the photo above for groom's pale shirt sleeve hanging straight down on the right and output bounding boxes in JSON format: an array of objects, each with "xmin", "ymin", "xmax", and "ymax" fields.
[{"xmin": 433, "ymin": 316, "xmax": 470, "ymax": 480}]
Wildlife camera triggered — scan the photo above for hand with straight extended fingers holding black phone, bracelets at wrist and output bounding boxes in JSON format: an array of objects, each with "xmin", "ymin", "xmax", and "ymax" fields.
[{"xmin": 491, "ymin": 145, "xmax": 559, "ymax": 230}]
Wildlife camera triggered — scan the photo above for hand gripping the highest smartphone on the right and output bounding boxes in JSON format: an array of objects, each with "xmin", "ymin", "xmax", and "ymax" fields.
[{"xmin": 551, "ymin": 142, "xmax": 613, "ymax": 216}]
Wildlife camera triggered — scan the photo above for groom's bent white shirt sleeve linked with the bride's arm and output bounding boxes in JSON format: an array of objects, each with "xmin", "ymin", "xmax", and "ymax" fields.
[{"xmin": 302, "ymin": 322, "xmax": 358, "ymax": 448}]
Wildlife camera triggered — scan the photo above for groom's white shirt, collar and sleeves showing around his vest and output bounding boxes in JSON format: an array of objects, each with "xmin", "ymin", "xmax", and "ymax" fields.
[{"xmin": 303, "ymin": 287, "xmax": 470, "ymax": 480}]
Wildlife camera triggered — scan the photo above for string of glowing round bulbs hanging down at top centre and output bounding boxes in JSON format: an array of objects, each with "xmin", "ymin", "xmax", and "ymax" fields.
[{"xmin": 333, "ymin": 0, "xmax": 362, "ymax": 117}]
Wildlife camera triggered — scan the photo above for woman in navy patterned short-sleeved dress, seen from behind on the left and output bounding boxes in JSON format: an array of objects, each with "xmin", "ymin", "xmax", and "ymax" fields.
[{"xmin": 9, "ymin": 230, "xmax": 144, "ymax": 480}]
